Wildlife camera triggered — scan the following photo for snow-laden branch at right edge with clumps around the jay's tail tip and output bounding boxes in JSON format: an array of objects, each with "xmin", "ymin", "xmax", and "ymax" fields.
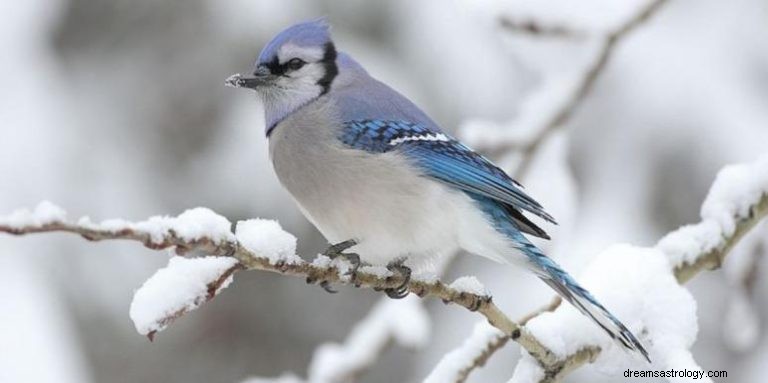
[{"xmin": 504, "ymin": 156, "xmax": 768, "ymax": 382}]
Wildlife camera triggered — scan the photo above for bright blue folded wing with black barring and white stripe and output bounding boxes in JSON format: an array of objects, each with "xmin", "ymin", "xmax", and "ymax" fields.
[{"xmin": 339, "ymin": 120, "xmax": 555, "ymax": 236}]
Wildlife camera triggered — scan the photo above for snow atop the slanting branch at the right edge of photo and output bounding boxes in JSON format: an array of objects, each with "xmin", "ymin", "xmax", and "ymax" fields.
[{"xmin": 657, "ymin": 156, "xmax": 768, "ymax": 267}]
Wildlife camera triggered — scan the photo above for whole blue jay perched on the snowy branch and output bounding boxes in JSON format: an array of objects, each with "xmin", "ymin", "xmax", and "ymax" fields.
[{"xmin": 227, "ymin": 20, "xmax": 648, "ymax": 359}]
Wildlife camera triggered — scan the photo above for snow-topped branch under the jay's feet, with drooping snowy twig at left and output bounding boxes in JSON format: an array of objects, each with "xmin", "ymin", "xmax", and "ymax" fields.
[{"xmin": 0, "ymin": 202, "xmax": 554, "ymax": 362}]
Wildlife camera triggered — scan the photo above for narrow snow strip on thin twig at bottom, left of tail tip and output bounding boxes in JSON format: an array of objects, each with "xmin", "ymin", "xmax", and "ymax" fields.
[{"xmin": 424, "ymin": 320, "xmax": 504, "ymax": 383}]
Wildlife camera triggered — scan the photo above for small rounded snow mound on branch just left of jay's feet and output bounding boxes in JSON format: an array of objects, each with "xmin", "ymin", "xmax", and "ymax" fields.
[{"xmin": 235, "ymin": 218, "xmax": 302, "ymax": 264}]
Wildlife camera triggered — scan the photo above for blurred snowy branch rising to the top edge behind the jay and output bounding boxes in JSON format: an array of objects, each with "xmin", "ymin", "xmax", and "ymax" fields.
[{"xmin": 460, "ymin": 0, "xmax": 667, "ymax": 178}]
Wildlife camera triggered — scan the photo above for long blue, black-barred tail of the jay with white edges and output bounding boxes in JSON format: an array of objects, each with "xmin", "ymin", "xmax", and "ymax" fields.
[{"xmin": 520, "ymin": 242, "xmax": 651, "ymax": 363}]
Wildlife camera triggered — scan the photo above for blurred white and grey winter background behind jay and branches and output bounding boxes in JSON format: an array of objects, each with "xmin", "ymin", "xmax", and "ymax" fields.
[{"xmin": 0, "ymin": 0, "xmax": 768, "ymax": 383}]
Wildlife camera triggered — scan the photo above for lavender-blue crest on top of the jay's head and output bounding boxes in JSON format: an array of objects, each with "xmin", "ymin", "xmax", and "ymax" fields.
[{"xmin": 258, "ymin": 18, "xmax": 331, "ymax": 64}]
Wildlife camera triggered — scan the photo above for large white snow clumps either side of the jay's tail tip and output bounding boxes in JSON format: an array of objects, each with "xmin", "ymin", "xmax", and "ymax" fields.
[{"xmin": 527, "ymin": 245, "xmax": 698, "ymax": 376}]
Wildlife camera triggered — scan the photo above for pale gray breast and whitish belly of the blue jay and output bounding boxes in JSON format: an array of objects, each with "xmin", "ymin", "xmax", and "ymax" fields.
[{"xmin": 270, "ymin": 97, "xmax": 464, "ymax": 263}]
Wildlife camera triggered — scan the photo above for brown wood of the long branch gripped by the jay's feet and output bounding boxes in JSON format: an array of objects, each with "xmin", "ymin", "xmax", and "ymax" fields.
[{"xmin": 0, "ymin": 212, "xmax": 556, "ymax": 363}]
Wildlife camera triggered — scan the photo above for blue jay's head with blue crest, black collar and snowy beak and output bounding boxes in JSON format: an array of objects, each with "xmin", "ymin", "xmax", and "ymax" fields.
[{"xmin": 226, "ymin": 19, "xmax": 339, "ymax": 134}]
